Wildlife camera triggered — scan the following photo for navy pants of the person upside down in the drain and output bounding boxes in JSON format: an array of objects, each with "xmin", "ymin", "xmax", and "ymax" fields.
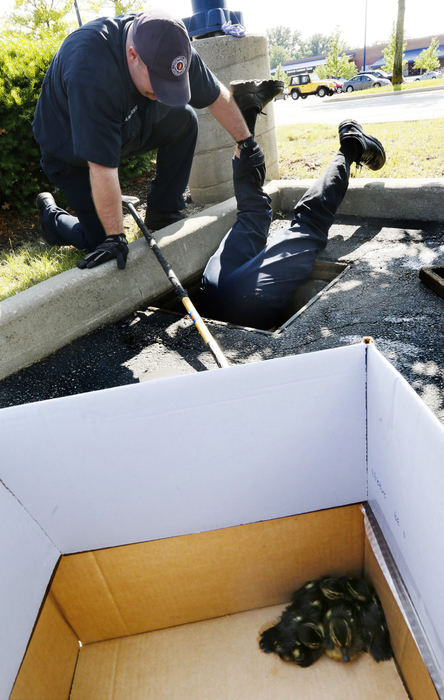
[{"xmin": 197, "ymin": 151, "xmax": 351, "ymax": 329}]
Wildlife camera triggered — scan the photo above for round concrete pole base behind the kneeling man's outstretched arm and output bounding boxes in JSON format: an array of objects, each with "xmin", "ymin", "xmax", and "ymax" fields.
[{"xmin": 189, "ymin": 35, "xmax": 279, "ymax": 204}]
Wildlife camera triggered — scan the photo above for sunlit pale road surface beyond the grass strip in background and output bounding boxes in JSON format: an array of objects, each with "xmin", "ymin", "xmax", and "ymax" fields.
[{"xmin": 273, "ymin": 88, "xmax": 444, "ymax": 126}]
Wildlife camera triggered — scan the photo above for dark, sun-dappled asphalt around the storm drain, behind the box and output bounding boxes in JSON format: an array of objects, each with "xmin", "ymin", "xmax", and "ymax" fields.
[{"xmin": 0, "ymin": 217, "xmax": 444, "ymax": 421}]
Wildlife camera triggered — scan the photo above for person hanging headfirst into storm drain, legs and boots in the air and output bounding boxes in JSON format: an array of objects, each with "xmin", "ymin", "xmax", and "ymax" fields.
[{"xmin": 196, "ymin": 81, "xmax": 386, "ymax": 330}]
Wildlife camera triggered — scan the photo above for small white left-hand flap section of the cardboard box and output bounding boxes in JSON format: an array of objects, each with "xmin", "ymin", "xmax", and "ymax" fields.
[{"xmin": 0, "ymin": 482, "xmax": 60, "ymax": 698}]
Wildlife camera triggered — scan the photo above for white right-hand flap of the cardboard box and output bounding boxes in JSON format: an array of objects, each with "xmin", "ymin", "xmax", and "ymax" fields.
[{"xmin": 368, "ymin": 347, "xmax": 444, "ymax": 691}]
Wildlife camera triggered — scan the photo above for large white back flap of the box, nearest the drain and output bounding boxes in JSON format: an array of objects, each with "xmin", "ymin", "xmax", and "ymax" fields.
[{"xmin": 0, "ymin": 344, "xmax": 367, "ymax": 553}]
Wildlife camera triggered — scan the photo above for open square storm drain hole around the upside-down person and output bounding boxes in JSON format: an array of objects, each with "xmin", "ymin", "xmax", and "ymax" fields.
[{"xmin": 148, "ymin": 260, "xmax": 351, "ymax": 335}]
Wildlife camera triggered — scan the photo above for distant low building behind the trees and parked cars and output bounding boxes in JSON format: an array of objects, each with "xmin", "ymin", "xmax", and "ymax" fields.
[{"xmin": 271, "ymin": 34, "xmax": 444, "ymax": 75}]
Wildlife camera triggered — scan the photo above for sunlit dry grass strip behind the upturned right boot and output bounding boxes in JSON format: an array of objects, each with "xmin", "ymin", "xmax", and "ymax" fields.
[{"xmin": 276, "ymin": 119, "xmax": 444, "ymax": 179}]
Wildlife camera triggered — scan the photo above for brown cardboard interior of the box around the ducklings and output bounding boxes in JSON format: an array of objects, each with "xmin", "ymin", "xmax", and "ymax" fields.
[{"xmin": 11, "ymin": 505, "xmax": 438, "ymax": 700}]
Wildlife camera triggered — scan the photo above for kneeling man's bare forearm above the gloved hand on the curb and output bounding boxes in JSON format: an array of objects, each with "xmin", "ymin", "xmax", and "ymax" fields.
[{"xmin": 88, "ymin": 163, "xmax": 123, "ymax": 236}]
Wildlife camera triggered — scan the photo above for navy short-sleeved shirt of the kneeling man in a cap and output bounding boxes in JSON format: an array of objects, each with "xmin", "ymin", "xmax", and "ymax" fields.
[{"xmin": 33, "ymin": 14, "xmax": 220, "ymax": 168}]
